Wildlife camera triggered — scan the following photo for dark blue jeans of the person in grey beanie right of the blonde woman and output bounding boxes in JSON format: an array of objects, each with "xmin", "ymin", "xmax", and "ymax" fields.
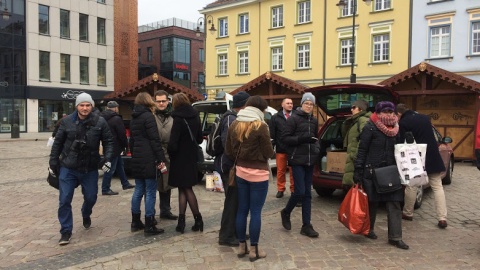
[{"xmin": 285, "ymin": 165, "xmax": 313, "ymax": 225}]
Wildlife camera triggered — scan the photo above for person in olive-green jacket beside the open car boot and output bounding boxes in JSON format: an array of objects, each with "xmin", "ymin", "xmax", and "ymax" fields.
[{"xmin": 342, "ymin": 100, "xmax": 372, "ymax": 190}]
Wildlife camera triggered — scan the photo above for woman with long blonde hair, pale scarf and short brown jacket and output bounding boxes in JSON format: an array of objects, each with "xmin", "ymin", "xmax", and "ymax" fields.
[{"xmin": 225, "ymin": 96, "xmax": 273, "ymax": 261}]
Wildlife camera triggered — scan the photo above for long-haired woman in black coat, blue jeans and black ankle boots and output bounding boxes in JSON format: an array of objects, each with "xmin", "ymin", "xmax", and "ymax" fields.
[{"xmin": 130, "ymin": 92, "xmax": 165, "ymax": 236}]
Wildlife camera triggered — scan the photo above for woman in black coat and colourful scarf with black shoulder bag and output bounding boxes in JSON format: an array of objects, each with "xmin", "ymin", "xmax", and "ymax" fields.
[{"xmin": 353, "ymin": 101, "xmax": 409, "ymax": 249}]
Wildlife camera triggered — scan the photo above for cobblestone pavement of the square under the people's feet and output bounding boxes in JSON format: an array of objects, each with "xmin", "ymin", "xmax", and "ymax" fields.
[{"xmin": 0, "ymin": 134, "xmax": 480, "ymax": 269}]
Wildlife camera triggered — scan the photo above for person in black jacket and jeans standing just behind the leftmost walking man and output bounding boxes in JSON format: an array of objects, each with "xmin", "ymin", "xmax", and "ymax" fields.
[{"xmin": 100, "ymin": 101, "xmax": 135, "ymax": 195}]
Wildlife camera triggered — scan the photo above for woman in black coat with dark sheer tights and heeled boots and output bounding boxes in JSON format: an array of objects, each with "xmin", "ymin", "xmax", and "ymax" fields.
[{"xmin": 167, "ymin": 93, "xmax": 203, "ymax": 233}]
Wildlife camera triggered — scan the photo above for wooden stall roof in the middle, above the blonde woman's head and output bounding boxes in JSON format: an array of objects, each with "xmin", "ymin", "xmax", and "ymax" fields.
[{"xmin": 230, "ymin": 71, "xmax": 308, "ymax": 95}]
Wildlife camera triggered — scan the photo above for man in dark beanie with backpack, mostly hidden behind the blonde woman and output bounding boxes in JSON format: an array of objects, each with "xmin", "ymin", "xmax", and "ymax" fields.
[{"xmin": 215, "ymin": 91, "xmax": 250, "ymax": 247}]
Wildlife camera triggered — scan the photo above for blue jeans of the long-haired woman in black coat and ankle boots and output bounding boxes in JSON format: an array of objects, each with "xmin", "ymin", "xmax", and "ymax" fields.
[{"xmin": 132, "ymin": 178, "xmax": 157, "ymax": 217}]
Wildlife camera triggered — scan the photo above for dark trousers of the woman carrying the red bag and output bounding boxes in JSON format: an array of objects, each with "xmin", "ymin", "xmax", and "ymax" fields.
[{"xmin": 368, "ymin": 202, "xmax": 402, "ymax": 241}]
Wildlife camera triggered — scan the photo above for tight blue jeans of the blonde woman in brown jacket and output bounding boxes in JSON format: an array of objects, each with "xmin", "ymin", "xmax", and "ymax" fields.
[{"xmin": 235, "ymin": 176, "xmax": 268, "ymax": 245}]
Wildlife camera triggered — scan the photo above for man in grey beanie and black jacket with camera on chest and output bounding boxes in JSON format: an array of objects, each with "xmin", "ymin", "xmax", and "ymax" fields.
[{"xmin": 48, "ymin": 93, "xmax": 113, "ymax": 245}]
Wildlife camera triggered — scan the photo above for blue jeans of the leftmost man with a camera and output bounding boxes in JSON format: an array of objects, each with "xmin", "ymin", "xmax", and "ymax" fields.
[{"xmin": 58, "ymin": 167, "xmax": 98, "ymax": 233}]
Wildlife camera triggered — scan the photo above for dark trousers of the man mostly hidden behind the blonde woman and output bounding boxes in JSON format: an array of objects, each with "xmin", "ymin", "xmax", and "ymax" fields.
[{"xmin": 218, "ymin": 174, "xmax": 238, "ymax": 245}]
